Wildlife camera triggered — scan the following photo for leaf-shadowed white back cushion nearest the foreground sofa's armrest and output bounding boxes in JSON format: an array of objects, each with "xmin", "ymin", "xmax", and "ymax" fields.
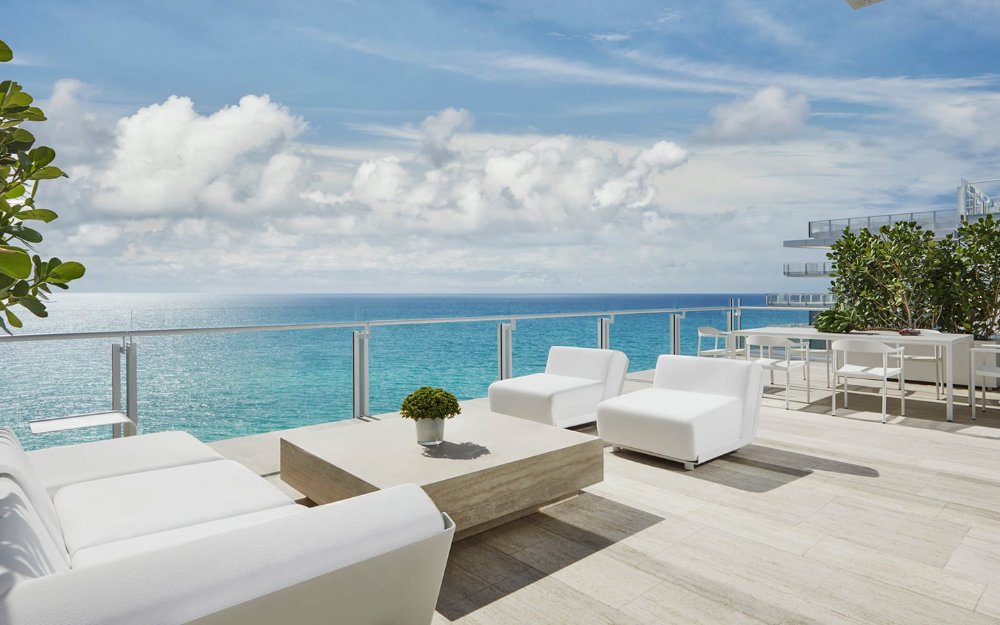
[{"xmin": 0, "ymin": 476, "xmax": 69, "ymax": 595}]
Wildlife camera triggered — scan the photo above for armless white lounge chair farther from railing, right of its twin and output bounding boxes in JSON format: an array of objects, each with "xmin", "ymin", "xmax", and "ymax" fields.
[{"xmin": 597, "ymin": 356, "xmax": 763, "ymax": 470}]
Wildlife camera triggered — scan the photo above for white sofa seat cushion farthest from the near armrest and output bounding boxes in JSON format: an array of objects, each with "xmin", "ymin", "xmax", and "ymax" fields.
[{"xmin": 28, "ymin": 432, "xmax": 223, "ymax": 497}]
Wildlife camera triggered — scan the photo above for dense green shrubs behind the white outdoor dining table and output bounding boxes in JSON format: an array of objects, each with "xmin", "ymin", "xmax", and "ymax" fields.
[{"xmin": 832, "ymin": 215, "xmax": 1000, "ymax": 339}]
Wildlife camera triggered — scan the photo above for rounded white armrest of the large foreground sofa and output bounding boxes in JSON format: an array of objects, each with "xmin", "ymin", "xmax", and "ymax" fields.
[{"xmin": 0, "ymin": 486, "xmax": 454, "ymax": 625}]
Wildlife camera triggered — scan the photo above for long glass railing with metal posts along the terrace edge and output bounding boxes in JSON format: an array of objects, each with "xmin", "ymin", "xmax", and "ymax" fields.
[{"xmin": 0, "ymin": 296, "xmax": 809, "ymax": 449}]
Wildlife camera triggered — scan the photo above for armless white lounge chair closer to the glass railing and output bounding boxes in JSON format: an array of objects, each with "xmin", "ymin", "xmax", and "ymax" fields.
[{"xmin": 488, "ymin": 347, "xmax": 628, "ymax": 427}]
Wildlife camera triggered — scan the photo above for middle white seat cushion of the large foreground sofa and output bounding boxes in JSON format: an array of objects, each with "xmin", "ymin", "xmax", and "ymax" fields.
[{"xmin": 54, "ymin": 460, "xmax": 291, "ymax": 557}]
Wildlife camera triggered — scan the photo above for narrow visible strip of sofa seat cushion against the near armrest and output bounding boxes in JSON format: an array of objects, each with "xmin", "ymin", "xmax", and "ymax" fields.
[{"xmin": 73, "ymin": 503, "xmax": 308, "ymax": 569}]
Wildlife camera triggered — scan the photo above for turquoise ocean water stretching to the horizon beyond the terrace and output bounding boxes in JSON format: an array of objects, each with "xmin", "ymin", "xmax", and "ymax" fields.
[{"xmin": 0, "ymin": 294, "xmax": 808, "ymax": 448}]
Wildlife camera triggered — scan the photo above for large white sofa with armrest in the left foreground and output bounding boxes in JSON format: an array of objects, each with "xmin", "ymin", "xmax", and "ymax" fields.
[{"xmin": 0, "ymin": 428, "xmax": 454, "ymax": 625}]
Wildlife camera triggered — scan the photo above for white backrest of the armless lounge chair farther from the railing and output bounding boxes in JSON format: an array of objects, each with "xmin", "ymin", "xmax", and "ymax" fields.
[{"xmin": 653, "ymin": 354, "xmax": 764, "ymax": 439}]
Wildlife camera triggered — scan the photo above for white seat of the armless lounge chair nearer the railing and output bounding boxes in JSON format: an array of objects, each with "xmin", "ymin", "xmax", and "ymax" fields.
[{"xmin": 489, "ymin": 373, "xmax": 604, "ymax": 426}]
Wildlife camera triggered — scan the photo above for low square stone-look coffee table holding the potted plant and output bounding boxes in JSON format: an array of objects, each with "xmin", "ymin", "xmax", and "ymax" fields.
[{"xmin": 281, "ymin": 412, "xmax": 604, "ymax": 540}]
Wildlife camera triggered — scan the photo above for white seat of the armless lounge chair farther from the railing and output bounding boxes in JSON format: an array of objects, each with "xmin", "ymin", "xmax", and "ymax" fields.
[{"xmin": 597, "ymin": 388, "xmax": 743, "ymax": 462}]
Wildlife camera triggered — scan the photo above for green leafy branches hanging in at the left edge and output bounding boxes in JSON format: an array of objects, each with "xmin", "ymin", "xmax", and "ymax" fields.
[{"xmin": 0, "ymin": 41, "xmax": 85, "ymax": 334}]
